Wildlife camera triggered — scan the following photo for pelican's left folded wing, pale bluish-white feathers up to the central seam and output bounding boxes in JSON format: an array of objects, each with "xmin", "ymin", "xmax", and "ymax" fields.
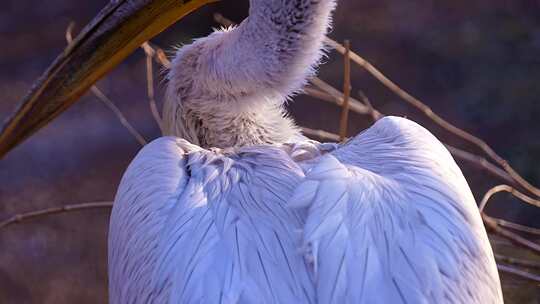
[{"xmin": 109, "ymin": 138, "xmax": 315, "ymax": 303}]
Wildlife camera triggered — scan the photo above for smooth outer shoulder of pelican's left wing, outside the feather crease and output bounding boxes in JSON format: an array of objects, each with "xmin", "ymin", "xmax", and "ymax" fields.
[{"xmin": 109, "ymin": 137, "xmax": 205, "ymax": 303}]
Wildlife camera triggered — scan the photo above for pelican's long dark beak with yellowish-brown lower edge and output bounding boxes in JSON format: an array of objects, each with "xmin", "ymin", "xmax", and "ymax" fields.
[{"xmin": 0, "ymin": 0, "xmax": 216, "ymax": 158}]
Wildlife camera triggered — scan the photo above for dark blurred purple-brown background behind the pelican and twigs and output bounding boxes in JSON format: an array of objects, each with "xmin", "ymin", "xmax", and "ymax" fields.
[{"xmin": 0, "ymin": 0, "xmax": 540, "ymax": 303}]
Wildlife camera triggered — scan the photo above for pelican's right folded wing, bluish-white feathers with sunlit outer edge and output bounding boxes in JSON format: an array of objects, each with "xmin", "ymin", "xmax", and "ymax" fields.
[{"xmin": 291, "ymin": 117, "xmax": 502, "ymax": 303}]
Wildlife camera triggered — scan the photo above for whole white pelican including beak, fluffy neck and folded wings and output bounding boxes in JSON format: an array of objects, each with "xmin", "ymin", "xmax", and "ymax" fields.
[{"xmin": 0, "ymin": 0, "xmax": 503, "ymax": 304}]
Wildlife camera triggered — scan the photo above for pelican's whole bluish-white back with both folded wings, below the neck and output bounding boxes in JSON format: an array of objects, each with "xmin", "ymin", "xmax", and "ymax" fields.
[{"xmin": 109, "ymin": 118, "xmax": 502, "ymax": 304}]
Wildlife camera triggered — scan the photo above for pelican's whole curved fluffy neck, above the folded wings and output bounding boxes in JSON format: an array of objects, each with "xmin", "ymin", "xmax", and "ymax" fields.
[{"xmin": 163, "ymin": 0, "xmax": 335, "ymax": 148}]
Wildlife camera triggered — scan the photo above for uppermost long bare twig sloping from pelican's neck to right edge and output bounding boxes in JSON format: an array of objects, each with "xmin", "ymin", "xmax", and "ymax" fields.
[{"xmin": 325, "ymin": 38, "xmax": 540, "ymax": 197}]
